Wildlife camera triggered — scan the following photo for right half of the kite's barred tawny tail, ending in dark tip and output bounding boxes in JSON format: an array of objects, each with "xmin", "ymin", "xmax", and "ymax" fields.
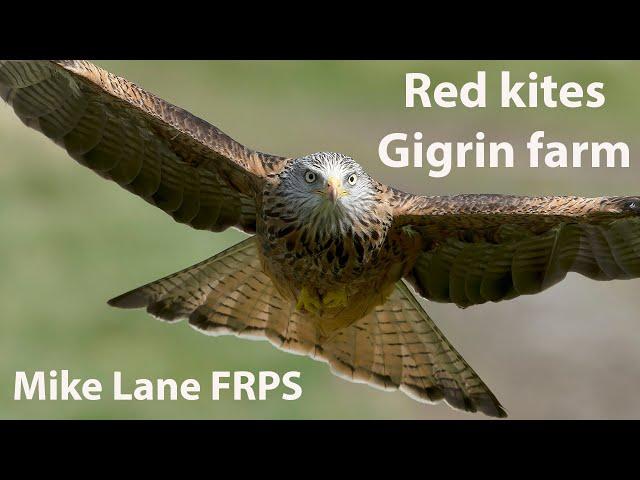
[{"xmin": 321, "ymin": 281, "xmax": 507, "ymax": 418}]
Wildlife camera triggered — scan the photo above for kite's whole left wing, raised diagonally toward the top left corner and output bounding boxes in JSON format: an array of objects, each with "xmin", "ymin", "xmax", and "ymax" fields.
[{"xmin": 0, "ymin": 61, "xmax": 287, "ymax": 232}]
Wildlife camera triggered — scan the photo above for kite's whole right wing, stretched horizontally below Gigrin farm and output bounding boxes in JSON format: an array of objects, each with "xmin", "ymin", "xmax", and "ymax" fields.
[{"xmin": 391, "ymin": 191, "xmax": 640, "ymax": 307}]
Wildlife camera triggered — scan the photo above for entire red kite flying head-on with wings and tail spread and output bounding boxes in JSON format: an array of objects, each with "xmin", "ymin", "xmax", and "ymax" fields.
[{"xmin": 0, "ymin": 61, "xmax": 640, "ymax": 417}]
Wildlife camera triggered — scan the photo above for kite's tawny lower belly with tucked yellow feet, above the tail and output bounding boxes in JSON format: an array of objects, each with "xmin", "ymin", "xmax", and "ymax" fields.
[{"xmin": 260, "ymin": 230, "xmax": 418, "ymax": 336}]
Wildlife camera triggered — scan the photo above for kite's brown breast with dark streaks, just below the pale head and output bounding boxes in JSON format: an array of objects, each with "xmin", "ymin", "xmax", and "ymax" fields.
[{"xmin": 257, "ymin": 191, "xmax": 417, "ymax": 312}]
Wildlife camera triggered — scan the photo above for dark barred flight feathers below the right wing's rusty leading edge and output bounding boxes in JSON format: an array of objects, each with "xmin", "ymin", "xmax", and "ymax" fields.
[{"xmin": 406, "ymin": 218, "xmax": 640, "ymax": 307}]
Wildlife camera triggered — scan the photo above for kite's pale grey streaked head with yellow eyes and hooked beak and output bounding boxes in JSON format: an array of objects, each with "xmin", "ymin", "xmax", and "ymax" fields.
[{"xmin": 282, "ymin": 152, "xmax": 376, "ymax": 232}]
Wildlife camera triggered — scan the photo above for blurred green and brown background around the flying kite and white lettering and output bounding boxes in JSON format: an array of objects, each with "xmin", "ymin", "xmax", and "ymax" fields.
[{"xmin": 0, "ymin": 61, "xmax": 640, "ymax": 419}]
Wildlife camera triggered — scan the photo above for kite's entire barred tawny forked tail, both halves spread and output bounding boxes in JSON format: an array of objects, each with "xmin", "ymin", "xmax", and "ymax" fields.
[{"xmin": 109, "ymin": 237, "xmax": 506, "ymax": 417}]
